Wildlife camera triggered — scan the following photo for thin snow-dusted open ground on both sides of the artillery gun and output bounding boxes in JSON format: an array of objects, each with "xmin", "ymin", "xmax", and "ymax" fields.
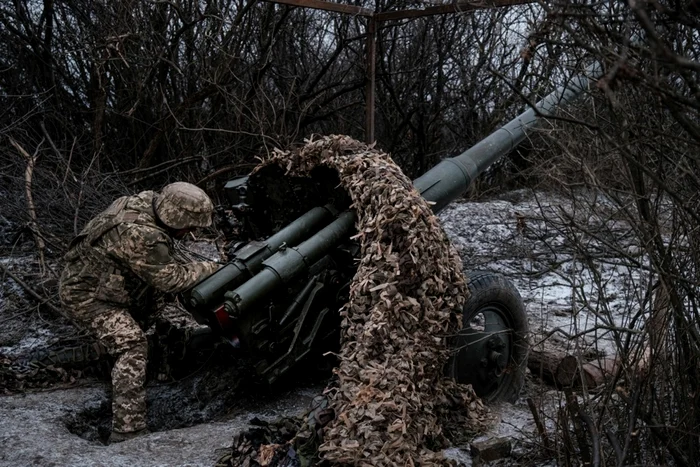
[{"xmin": 0, "ymin": 191, "xmax": 650, "ymax": 467}]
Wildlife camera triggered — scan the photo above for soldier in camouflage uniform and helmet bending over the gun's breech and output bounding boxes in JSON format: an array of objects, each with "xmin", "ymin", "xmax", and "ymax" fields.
[{"xmin": 60, "ymin": 182, "xmax": 219, "ymax": 443}]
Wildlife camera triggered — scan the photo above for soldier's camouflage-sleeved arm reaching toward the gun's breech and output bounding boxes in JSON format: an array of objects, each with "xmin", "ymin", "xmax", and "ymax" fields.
[{"xmin": 112, "ymin": 225, "xmax": 220, "ymax": 293}]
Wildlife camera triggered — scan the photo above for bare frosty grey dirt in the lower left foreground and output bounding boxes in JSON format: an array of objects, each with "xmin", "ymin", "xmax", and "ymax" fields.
[{"xmin": 0, "ymin": 384, "xmax": 320, "ymax": 467}]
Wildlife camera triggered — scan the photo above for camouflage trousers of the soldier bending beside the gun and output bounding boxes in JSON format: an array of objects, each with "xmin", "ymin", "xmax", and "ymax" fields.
[{"xmin": 61, "ymin": 297, "xmax": 148, "ymax": 433}]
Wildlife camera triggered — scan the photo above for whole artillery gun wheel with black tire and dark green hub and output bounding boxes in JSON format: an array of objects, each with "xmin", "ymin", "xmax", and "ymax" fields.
[{"xmin": 446, "ymin": 272, "xmax": 528, "ymax": 402}]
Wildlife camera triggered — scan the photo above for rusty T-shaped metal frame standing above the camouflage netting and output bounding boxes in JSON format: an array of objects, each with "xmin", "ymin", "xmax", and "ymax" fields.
[{"xmin": 264, "ymin": 0, "xmax": 538, "ymax": 143}]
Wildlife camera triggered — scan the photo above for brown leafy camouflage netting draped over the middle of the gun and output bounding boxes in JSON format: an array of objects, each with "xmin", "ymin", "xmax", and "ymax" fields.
[{"xmin": 221, "ymin": 136, "xmax": 486, "ymax": 466}]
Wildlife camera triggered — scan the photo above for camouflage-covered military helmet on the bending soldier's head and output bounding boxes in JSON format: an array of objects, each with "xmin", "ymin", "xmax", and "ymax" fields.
[{"xmin": 153, "ymin": 182, "xmax": 214, "ymax": 229}]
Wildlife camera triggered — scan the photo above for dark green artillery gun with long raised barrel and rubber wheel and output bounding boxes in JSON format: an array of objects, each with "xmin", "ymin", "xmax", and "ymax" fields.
[{"xmin": 185, "ymin": 67, "xmax": 600, "ymax": 401}]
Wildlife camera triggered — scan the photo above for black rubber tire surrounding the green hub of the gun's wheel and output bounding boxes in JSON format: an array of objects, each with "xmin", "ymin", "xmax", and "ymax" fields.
[{"xmin": 446, "ymin": 271, "xmax": 529, "ymax": 403}]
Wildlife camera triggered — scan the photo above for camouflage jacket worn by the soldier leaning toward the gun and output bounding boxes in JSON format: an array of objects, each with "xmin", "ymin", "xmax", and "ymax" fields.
[{"xmin": 61, "ymin": 191, "xmax": 219, "ymax": 307}]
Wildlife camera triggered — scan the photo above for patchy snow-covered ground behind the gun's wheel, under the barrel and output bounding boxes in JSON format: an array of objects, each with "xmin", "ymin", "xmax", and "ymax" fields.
[{"xmin": 440, "ymin": 190, "xmax": 650, "ymax": 355}]
